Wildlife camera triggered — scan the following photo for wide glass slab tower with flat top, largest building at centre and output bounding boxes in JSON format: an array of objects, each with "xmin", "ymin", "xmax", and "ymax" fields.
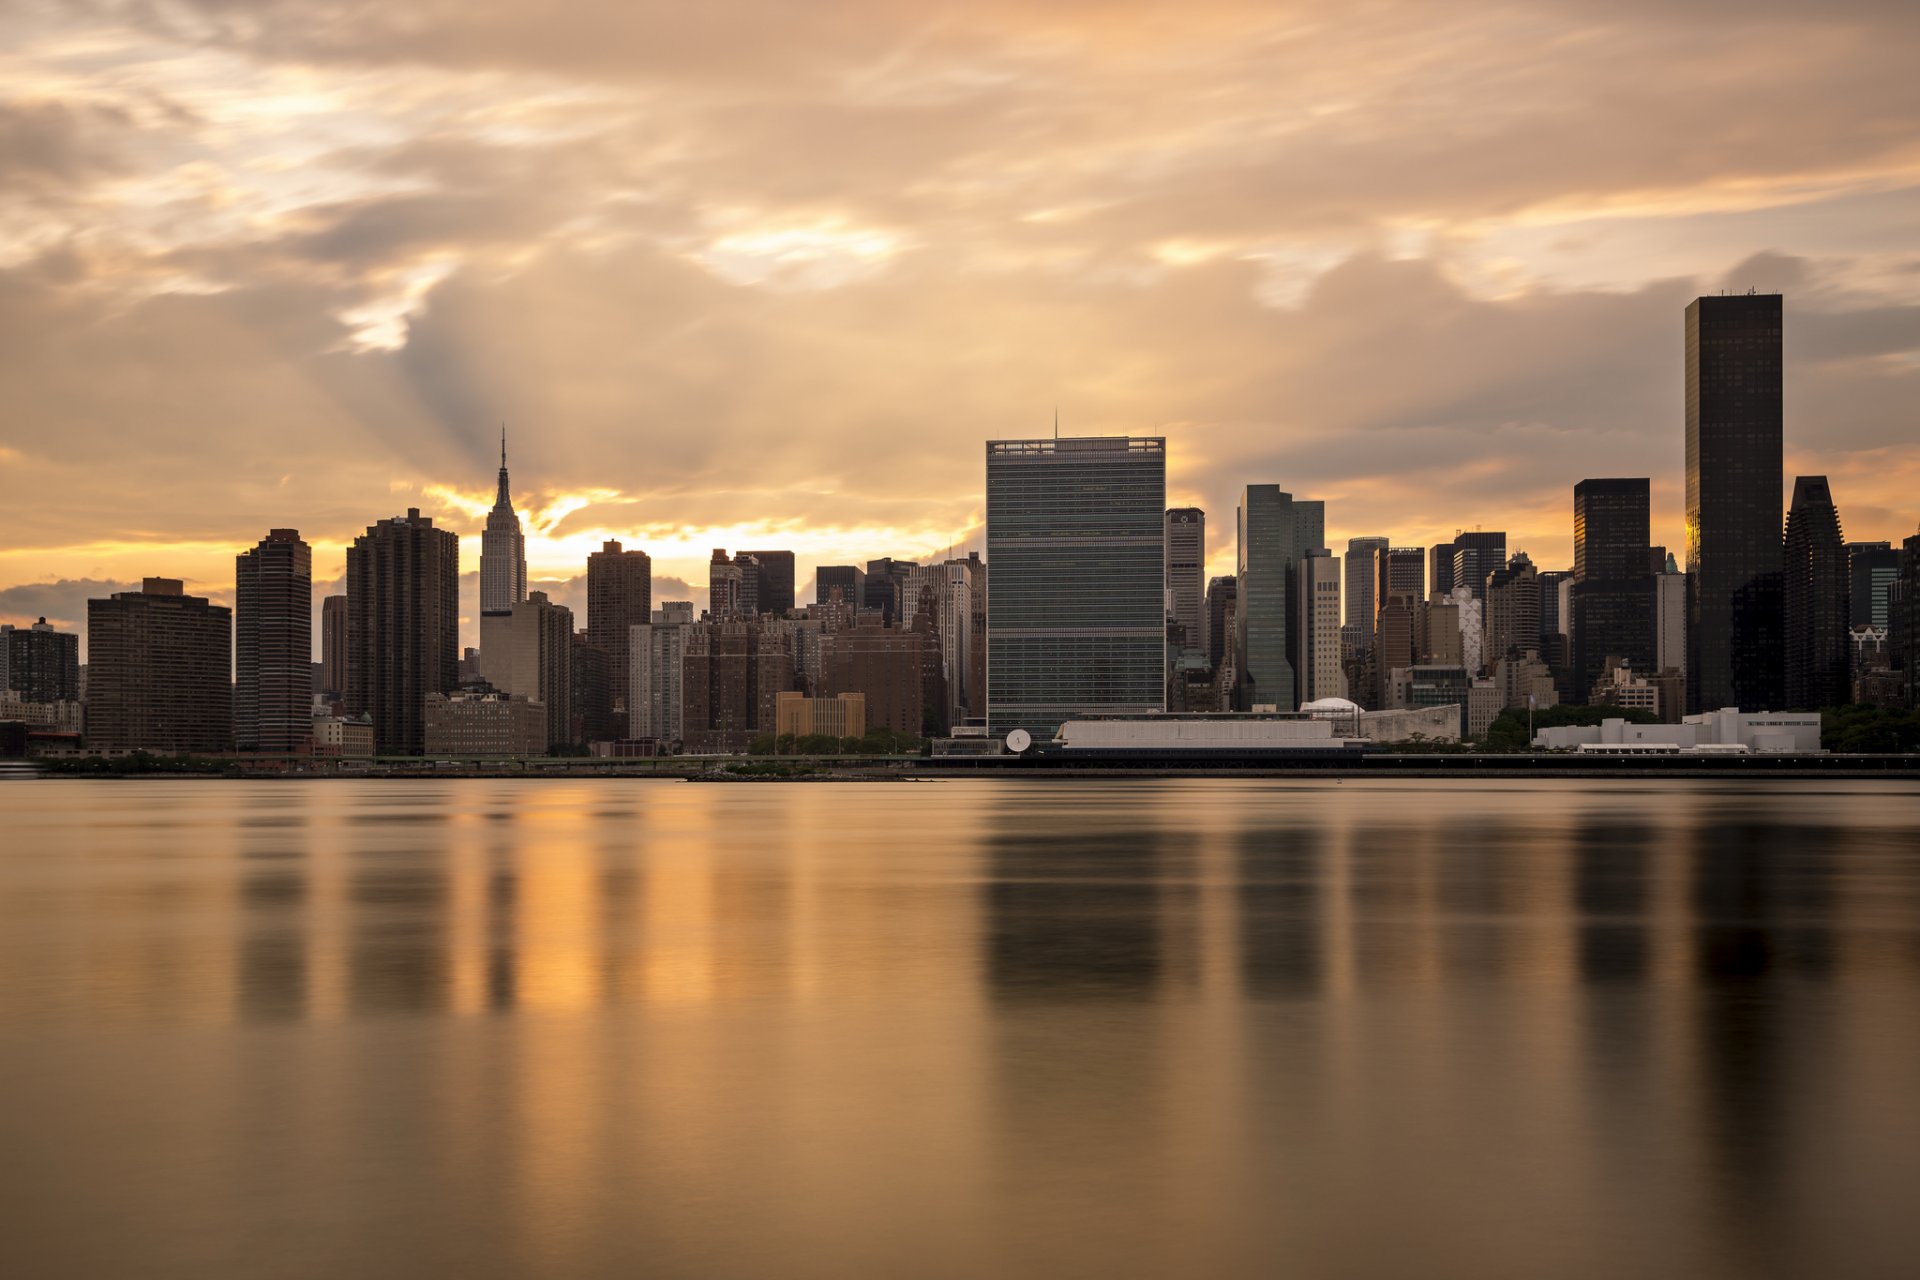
[{"xmin": 983, "ymin": 436, "xmax": 1167, "ymax": 741}]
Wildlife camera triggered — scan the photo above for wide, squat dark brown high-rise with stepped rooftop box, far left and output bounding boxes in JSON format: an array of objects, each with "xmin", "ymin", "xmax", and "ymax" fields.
[{"xmin": 86, "ymin": 578, "xmax": 232, "ymax": 752}]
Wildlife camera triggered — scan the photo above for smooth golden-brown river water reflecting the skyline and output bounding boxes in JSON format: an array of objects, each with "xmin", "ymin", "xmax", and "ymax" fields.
[{"xmin": 0, "ymin": 779, "xmax": 1920, "ymax": 1280}]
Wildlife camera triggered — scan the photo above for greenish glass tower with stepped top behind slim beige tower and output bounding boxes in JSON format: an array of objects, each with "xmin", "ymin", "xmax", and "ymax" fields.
[{"xmin": 1235, "ymin": 484, "xmax": 1327, "ymax": 712}]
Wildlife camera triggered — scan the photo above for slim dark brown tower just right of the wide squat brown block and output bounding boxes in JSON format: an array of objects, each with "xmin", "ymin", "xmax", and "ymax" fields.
[{"xmin": 234, "ymin": 530, "xmax": 313, "ymax": 756}]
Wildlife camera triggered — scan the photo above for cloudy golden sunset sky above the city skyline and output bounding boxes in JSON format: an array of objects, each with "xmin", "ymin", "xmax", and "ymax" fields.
[{"xmin": 0, "ymin": 0, "xmax": 1920, "ymax": 644}]
